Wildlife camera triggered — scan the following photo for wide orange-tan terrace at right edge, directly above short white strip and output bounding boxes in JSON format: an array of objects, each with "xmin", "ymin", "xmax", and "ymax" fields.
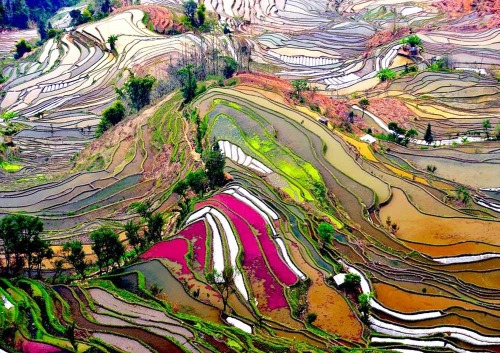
[{"xmin": 380, "ymin": 189, "xmax": 500, "ymax": 249}]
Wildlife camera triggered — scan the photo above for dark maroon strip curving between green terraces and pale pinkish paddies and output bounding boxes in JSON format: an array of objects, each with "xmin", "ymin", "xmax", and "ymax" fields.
[{"xmin": 54, "ymin": 286, "xmax": 184, "ymax": 353}]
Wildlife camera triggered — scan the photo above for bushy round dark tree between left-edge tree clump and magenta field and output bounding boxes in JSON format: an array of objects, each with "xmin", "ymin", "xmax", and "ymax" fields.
[{"xmin": 90, "ymin": 226, "xmax": 125, "ymax": 273}]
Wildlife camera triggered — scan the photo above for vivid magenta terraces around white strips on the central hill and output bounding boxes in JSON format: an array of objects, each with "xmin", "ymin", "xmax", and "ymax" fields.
[{"xmin": 141, "ymin": 194, "xmax": 298, "ymax": 310}]
